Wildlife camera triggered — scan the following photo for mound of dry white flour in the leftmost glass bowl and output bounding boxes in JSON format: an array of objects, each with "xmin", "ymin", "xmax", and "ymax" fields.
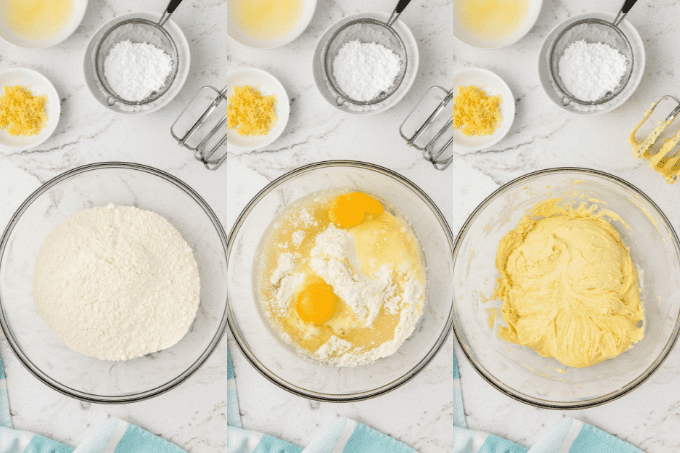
[{"xmin": 33, "ymin": 204, "xmax": 200, "ymax": 360}]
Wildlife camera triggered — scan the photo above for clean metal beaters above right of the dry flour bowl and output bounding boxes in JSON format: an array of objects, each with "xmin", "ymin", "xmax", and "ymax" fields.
[{"xmin": 170, "ymin": 82, "xmax": 227, "ymax": 170}]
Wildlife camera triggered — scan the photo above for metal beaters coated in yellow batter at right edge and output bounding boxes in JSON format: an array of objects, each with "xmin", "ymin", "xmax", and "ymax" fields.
[{"xmin": 629, "ymin": 95, "xmax": 680, "ymax": 184}]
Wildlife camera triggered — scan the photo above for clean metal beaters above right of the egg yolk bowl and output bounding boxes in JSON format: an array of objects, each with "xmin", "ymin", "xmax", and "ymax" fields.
[{"xmin": 399, "ymin": 86, "xmax": 453, "ymax": 170}]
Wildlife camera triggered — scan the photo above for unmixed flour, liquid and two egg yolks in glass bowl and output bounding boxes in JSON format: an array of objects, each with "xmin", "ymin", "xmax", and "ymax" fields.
[{"xmin": 255, "ymin": 190, "xmax": 427, "ymax": 367}]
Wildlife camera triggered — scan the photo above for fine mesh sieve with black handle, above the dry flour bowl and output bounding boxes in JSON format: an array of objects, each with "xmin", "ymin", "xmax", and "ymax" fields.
[{"xmin": 94, "ymin": 0, "xmax": 182, "ymax": 105}]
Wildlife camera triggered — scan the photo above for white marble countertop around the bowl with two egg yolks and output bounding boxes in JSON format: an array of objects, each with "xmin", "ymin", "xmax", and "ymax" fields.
[{"xmin": 227, "ymin": 0, "xmax": 453, "ymax": 453}]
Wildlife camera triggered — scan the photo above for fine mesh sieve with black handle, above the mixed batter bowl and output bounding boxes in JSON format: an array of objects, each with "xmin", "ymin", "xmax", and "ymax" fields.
[{"xmin": 548, "ymin": 0, "xmax": 637, "ymax": 105}]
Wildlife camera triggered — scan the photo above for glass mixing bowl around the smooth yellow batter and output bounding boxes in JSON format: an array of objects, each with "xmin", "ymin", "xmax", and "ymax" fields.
[{"xmin": 453, "ymin": 168, "xmax": 680, "ymax": 409}]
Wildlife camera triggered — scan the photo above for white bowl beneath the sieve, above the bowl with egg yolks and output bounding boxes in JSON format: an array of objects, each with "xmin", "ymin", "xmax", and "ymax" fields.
[{"xmin": 312, "ymin": 11, "xmax": 420, "ymax": 115}]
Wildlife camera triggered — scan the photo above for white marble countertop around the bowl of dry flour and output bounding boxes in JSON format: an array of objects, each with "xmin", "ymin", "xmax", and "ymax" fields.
[{"xmin": 0, "ymin": 0, "xmax": 227, "ymax": 452}]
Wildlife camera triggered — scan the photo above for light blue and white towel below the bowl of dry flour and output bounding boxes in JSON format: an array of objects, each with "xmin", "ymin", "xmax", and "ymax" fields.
[{"xmin": 0, "ymin": 357, "xmax": 186, "ymax": 453}]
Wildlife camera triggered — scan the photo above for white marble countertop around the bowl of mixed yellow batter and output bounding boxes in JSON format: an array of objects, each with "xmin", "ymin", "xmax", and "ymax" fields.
[{"xmin": 451, "ymin": 0, "xmax": 680, "ymax": 453}]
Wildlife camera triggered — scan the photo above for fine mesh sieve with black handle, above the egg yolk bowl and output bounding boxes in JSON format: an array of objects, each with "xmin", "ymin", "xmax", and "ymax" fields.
[{"xmin": 322, "ymin": 0, "xmax": 411, "ymax": 105}]
